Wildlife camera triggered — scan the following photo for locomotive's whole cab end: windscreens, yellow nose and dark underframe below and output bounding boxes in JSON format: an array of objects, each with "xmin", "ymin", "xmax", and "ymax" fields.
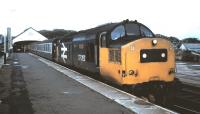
[{"xmin": 99, "ymin": 21, "xmax": 175, "ymax": 104}]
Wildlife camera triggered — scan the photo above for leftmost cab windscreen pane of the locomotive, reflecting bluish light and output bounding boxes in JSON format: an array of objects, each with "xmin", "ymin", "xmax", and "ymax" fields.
[{"xmin": 111, "ymin": 25, "xmax": 125, "ymax": 40}]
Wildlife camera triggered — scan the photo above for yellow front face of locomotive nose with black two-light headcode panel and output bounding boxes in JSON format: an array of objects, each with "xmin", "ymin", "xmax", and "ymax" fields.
[{"xmin": 121, "ymin": 38, "xmax": 175, "ymax": 85}]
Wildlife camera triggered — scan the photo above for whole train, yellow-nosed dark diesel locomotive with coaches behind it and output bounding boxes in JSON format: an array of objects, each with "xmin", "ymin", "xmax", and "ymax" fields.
[{"xmin": 29, "ymin": 20, "xmax": 175, "ymax": 103}]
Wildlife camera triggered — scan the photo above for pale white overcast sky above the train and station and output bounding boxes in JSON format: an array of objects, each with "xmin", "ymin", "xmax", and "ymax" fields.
[{"xmin": 0, "ymin": 0, "xmax": 200, "ymax": 39}]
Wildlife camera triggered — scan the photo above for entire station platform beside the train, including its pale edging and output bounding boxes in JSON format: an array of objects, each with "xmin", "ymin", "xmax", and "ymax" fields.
[{"xmin": 0, "ymin": 53, "xmax": 176, "ymax": 114}]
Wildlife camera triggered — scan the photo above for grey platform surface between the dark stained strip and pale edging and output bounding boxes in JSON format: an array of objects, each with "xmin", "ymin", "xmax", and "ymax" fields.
[{"xmin": 15, "ymin": 54, "xmax": 136, "ymax": 114}]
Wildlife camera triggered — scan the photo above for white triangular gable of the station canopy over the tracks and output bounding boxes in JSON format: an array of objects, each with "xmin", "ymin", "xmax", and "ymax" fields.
[{"xmin": 12, "ymin": 27, "xmax": 47, "ymax": 44}]
